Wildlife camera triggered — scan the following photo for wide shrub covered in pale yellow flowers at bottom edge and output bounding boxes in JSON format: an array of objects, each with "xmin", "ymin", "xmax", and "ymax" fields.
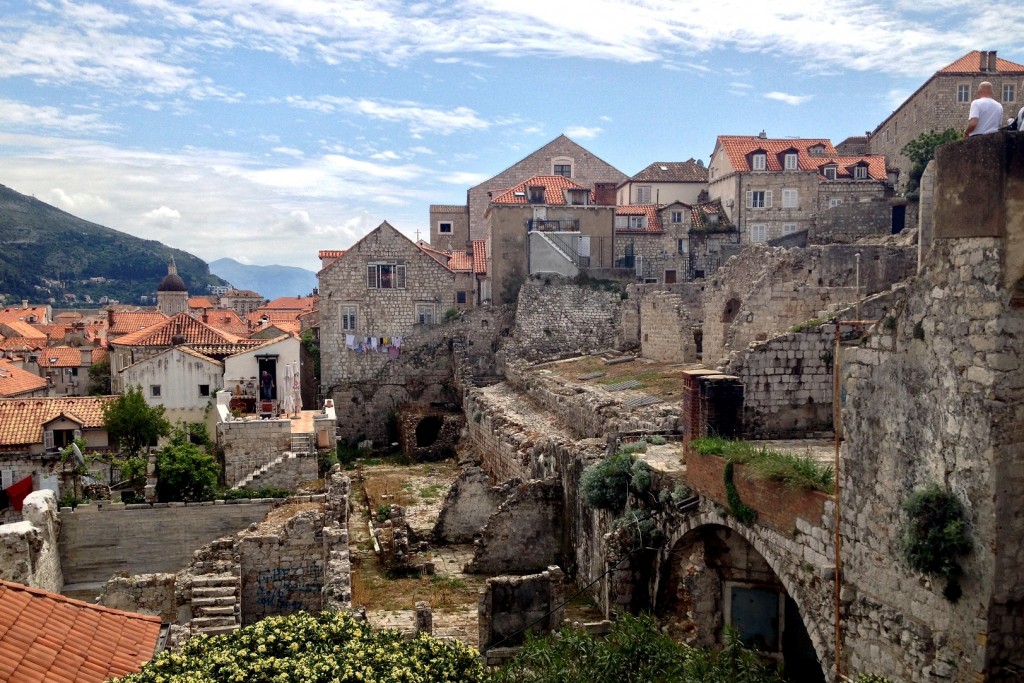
[{"xmin": 120, "ymin": 612, "xmax": 485, "ymax": 683}]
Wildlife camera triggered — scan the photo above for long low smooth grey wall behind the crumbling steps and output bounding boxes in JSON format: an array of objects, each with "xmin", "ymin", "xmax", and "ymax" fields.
[{"xmin": 59, "ymin": 500, "xmax": 280, "ymax": 584}]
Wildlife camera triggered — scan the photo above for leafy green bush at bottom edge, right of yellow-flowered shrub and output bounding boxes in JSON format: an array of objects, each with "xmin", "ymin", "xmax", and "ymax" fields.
[{"xmin": 490, "ymin": 614, "xmax": 782, "ymax": 683}]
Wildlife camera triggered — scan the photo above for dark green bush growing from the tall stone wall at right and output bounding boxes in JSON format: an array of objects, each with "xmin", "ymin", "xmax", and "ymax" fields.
[{"xmin": 903, "ymin": 484, "xmax": 972, "ymax": 602}]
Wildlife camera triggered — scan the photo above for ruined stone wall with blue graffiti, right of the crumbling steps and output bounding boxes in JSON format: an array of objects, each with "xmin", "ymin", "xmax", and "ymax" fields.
[{"xmin": 238, "ymin": 511, "xmax": 325, "ymax": 625}]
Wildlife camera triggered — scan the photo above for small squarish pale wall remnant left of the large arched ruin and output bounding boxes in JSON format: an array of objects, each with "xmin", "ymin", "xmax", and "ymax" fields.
[{"xmin": 640, "ymin": 292, "xmax": 700, "ymax": 362}]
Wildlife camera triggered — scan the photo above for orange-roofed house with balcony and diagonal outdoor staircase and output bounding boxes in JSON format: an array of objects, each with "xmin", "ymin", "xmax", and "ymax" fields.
[{"xmin": 484, "ymin": 175, "xmax": 615, "ymax": 303}]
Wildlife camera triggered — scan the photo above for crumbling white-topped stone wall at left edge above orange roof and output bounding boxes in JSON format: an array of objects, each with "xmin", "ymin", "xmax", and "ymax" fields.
[{"xmin": 0, "ymin": 489, "xmax": 65, "ymax": 593}]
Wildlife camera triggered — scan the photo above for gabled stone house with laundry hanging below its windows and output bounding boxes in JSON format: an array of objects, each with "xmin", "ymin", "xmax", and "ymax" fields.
[{"xmin": 317, "ymin": 222, "xmax": 456, "ymax": 387}]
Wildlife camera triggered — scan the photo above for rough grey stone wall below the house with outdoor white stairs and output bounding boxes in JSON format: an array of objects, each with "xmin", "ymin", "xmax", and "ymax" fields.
[{"xmin": 505, "ymin": 275, "xmax": 623, "ymax": 360}]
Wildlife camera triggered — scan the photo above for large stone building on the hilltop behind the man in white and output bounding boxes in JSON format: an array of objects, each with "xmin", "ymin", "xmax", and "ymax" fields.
[{"xmin": 867, "ymin": 50, "xmax": 1024, "ymax": 188}]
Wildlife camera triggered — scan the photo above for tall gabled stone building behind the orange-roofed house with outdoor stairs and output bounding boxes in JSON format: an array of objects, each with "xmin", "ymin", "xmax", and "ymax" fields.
[{"xmin": 430, "ymin": 135, "xmax": 628, "ymax": 245}]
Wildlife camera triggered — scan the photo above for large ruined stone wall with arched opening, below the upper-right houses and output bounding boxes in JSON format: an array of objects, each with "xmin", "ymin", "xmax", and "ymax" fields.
[{"xmin": 703, "ymin": 245, "xmax": 916, "ymax": 367}]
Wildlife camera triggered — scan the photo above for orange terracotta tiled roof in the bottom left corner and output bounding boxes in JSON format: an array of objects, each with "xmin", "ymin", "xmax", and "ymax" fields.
[{"xmin": 0, "ymin": 581, "xmax": 161, "ymax": 683}]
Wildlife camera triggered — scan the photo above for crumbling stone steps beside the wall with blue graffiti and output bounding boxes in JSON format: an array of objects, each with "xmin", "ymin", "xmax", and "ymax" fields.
[{"xmin": 189, "ymin": 538, "xmax": 242, "ymax": 636}]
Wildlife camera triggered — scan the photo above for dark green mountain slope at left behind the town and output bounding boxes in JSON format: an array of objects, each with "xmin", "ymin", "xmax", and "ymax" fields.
[{"xmin": 0, "ymin": 185, "xmax": 226, "ymax": 307}]
